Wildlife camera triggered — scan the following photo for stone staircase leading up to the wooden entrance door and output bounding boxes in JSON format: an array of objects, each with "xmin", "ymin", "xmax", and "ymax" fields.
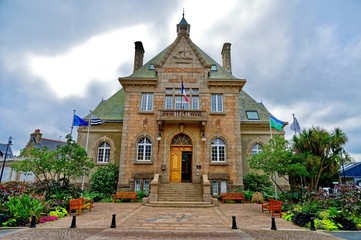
[{"xmin": 146, "ymin": 183, "xmax": 214, "ymax": 207}]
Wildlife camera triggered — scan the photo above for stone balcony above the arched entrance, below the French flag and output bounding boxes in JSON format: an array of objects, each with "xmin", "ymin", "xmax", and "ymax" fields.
[{"xmin": 157, "ymin": 109, "xmax": 207, "ymax": 122}]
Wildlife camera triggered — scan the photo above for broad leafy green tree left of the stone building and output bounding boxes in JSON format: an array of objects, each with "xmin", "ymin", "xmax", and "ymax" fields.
[{"xmin": 11, "ymin": 135, "xmax": 94, "ymax": 185}]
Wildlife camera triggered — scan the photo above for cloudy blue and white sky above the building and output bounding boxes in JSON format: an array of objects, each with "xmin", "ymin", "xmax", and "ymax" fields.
[{"xmin": 0, "ymin": 0, "xmax": 361, "ymax": 161}]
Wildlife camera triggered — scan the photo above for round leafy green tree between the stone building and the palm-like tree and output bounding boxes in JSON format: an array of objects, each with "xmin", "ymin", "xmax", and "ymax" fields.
[{"xmin": 249, "ymin": 135, "xmax": 308, "ymax": 190}]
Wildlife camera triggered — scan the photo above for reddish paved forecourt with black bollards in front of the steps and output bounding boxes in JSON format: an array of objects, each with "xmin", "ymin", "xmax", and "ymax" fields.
[{"xmin": 0, "ymin": 203, "xmax": 348, "ymax": 240}]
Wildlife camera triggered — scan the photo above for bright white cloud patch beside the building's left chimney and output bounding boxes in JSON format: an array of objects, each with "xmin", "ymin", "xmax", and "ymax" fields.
[{"xmin": 27, "ymin": 25, "xmax": 154, "ymax": 98}]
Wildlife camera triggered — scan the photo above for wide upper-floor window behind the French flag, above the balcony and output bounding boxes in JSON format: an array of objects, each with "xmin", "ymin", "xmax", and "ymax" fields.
[{"xmin": 164, "ymin": 88, "xmax": 199, "ymax": 110}]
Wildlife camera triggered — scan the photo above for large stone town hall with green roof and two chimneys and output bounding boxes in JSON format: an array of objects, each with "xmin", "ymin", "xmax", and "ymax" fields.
[{"xmin": 78, "ymin": 16, "xmax": 287, "ymax": 202}]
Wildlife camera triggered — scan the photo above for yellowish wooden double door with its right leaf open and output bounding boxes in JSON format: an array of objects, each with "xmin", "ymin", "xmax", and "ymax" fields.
[{"xmin": 170, "ymin": 146, "xmax": 192, "ymax": 183}]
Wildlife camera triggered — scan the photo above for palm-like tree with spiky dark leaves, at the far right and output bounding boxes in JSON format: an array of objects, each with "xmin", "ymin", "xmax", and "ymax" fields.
[{"xmin": 293, "ymin": 127, "xmax": 348, "ymax": 190}]
